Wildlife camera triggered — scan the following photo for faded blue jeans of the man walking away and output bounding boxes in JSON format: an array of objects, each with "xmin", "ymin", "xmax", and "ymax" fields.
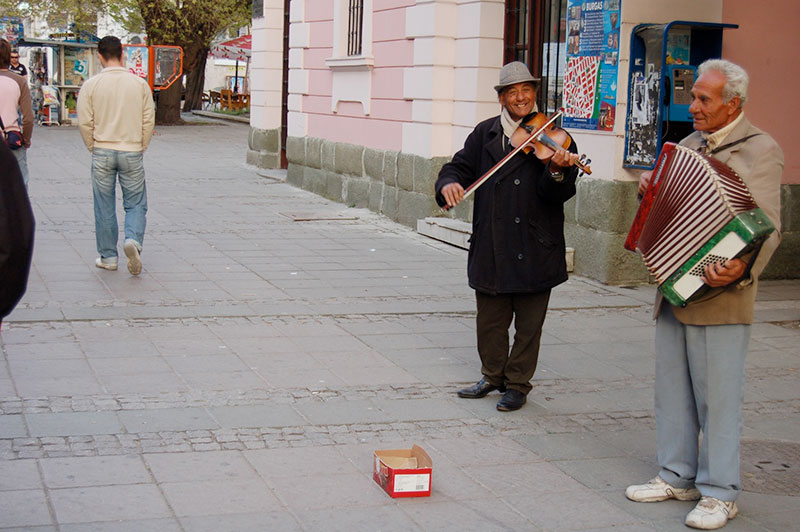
[{"xmin": 92, "ymin": 148, "xmax": 147, "ymax": 258}]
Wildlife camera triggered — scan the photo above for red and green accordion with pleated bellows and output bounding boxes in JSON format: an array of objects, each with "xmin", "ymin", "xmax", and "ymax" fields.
[{"xmin": 625, "ymin": 142, "xmax": 775, "ymax": 306}]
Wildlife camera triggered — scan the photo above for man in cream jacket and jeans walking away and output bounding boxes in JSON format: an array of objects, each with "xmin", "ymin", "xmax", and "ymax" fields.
[{"xmin": 78, "ymin": 36, "xmax": 155, "ymax": 275}]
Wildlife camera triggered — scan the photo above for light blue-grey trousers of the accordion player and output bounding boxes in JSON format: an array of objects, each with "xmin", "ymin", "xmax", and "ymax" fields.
[{"xmin": 655, "ymin": 303, "xmax": 750, "ymax": 501}]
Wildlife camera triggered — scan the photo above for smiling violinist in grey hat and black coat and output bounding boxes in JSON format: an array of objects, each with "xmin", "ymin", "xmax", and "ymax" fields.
[{"xmin": 436, "ymin": 61, "xmax": 579, "ymax": 411}]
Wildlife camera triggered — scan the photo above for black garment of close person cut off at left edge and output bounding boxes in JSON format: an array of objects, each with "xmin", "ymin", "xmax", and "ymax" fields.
[{"xmin": 0, "ymin": 141, "xmax": 34, "ymax": 322}]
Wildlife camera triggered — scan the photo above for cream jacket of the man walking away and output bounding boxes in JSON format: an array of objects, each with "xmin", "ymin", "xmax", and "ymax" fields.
[{"xmin": 78, "ymin": 67, "xmax": 155, "ymax": 151}]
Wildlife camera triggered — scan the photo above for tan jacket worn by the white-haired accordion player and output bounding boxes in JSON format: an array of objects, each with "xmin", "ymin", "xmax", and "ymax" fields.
[{"xmin": 655, "ymin": 117, "xmax": 783, "ymax": 325}]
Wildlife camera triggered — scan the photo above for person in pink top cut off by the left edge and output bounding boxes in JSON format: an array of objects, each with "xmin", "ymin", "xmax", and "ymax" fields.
[{"xmin": 0, "ymin": 39, "xmax": 33, "ymax": 187}]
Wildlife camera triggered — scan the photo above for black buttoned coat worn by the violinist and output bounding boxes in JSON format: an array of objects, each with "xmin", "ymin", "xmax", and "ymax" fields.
[{"xmin": 436, "ymin": 116, "xmax": 578, "ymax": 295}]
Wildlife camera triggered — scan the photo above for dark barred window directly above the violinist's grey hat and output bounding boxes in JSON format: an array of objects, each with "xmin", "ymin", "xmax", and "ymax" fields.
[{"xmin": 503, "ymin": 0, "xmax": 567, "ymax": 114}]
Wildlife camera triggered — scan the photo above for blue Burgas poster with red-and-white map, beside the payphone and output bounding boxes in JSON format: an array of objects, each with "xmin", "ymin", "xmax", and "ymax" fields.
[{"xmin": 562, "ymin": 0, "xmax": 622, "ymax": 131}]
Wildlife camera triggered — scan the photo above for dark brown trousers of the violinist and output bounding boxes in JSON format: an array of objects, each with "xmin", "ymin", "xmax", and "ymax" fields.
[{"xmin": 475, "ymin": 290, "xmax": 550, "ymax": 394}]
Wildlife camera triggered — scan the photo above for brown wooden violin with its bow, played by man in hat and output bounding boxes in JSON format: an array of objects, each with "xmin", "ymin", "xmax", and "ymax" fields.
[{"xmin": 442, "ymin": 111, "xmax": 592, "ymax": 211}]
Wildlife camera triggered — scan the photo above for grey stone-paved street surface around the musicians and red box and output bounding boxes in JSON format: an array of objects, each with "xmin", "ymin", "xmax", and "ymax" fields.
[{"xmin": 0, "ymin": 119, "xmax": 800, "ymax": 531}]
